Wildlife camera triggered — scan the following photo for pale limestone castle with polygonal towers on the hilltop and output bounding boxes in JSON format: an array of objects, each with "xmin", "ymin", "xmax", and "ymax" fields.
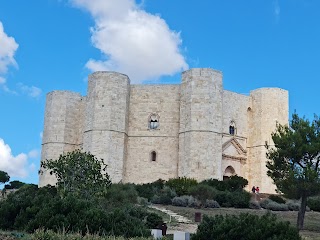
[{"xmin": 39, "ymin": 68, "xmax": 288, "ymax": 193}]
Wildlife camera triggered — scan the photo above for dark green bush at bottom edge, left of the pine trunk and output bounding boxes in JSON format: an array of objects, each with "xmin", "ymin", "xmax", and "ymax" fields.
[{"xmin": 191, "ymin": 213, "xmax": 301, "ymax": 240}]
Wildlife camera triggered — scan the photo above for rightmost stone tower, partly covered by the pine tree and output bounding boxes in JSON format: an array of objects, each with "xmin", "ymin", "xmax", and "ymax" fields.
[{"xmin": 245, "ymin": 88, "xmax": 289, "ymax": 193}]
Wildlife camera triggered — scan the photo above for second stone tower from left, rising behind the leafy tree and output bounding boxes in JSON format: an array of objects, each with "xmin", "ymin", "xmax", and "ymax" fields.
[{"xmin": 83, "ymin": 72, "xmax": 130, "ymax": 182}]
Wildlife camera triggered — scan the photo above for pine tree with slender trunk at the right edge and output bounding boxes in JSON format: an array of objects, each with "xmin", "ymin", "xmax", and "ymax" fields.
[{"xmin": 266, "ymin": 113, "xmax": 320, "ymax": 230}]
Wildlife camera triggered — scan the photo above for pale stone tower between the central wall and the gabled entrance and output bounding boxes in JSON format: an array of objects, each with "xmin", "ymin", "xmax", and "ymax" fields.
[{"xmin": 178, "ymin": 68, "xmax": 222, "ymax": 180}]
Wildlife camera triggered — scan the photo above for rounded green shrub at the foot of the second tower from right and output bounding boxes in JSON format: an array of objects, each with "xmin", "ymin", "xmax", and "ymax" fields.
[{"xmin": 165, "ymin": 177, "xmax": 198, "ymax": 196}]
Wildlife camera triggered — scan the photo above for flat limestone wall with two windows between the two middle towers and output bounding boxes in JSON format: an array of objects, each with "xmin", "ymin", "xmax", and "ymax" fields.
[{"xmin": 125, "ymin": 85, "xmax": 180, "ymax": 183}]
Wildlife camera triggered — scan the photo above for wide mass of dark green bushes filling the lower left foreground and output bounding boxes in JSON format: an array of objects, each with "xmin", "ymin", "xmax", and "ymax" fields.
[{"xmin": 0, "ymin": 185, "xmax": 161, "ymax": 237}]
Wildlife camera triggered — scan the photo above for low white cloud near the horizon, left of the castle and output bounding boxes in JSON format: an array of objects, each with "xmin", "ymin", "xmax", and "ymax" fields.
[{"xmin": 0, "ymin": 138, "xmax": 29, "ymax": 178}]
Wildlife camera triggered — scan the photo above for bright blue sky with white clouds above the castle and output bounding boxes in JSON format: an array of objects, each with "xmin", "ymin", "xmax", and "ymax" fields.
[{"xmin": 0, "ymin": 0, "xmax": 320, "ymax": 183}]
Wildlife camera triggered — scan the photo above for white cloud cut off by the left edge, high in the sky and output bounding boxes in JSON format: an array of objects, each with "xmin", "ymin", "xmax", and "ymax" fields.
[{"xmin": 0, "ymin": 21, "xmax": 19, "ymax": 78}]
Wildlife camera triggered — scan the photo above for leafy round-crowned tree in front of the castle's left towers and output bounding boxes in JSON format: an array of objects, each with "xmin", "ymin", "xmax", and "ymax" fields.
[{"xmin": 40, "ymin": 150, "xmax": 111, "ymax": 199}]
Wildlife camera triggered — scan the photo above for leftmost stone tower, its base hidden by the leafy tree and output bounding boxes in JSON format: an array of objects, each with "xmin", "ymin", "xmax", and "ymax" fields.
[{"xmin": 39, "ymin": 91, "xmax": 84, "ymax": 187}]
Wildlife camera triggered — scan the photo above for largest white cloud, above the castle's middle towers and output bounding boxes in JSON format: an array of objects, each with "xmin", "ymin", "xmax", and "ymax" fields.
[{"xmin": 69, "ymin": 0, "xmax": 188, "ymax": 83}]
